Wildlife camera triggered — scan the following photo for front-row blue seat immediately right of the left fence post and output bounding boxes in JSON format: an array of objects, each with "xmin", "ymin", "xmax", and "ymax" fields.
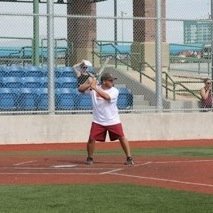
[{"xmin": 56, "ymin": 88, "xmax": 77, "ymax": 110}]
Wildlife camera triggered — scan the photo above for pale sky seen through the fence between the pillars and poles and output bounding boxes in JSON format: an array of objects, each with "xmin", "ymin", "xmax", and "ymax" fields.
[{"xmin": 0, "ymin": 0, "xmax": 211, "ymax": 43}]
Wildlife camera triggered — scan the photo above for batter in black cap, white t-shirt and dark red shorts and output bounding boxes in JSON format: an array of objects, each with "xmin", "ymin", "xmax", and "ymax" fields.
[{"xmin": 78, "ymin": 73, "xmax": 134, "ymax": 165}]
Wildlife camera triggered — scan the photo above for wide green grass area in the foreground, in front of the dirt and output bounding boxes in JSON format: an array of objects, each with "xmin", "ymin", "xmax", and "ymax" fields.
[{"xmin": 0, "ymin": 184, "xmax": 213, "ymax": 213}]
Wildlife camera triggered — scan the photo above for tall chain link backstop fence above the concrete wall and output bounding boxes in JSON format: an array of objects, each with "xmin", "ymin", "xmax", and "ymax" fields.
[{"xmin": 0, "ymin": 0, "xmax": 212, "ymax": 113}]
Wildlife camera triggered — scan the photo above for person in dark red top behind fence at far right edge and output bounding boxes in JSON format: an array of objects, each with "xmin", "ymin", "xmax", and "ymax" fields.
[{"xmin": 200, "ymin": 78, "xmax": 213, "ymax": 111}]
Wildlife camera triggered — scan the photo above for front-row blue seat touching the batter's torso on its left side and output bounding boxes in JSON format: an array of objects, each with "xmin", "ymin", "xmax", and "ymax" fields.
[{"xmin": 76, "ymin": 93, "xmax": 92, "ymax": 110}]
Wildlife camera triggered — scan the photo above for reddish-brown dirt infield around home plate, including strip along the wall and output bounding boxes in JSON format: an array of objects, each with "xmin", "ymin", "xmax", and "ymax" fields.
[{"xmin": 0, "ymin": 141, "xmax": 213, "ymax": 194}]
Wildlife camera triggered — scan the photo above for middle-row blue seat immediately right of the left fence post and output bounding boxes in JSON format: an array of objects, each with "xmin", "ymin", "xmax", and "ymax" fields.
[{"xmin": 56, "ymin": 77, "xmax": 78, "ymax": 88}]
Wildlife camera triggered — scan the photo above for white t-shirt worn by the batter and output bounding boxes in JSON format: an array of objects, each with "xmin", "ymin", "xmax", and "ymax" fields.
[{"xmin": 90, "ymin": 86, "xmax": 120, "ymax": 126}]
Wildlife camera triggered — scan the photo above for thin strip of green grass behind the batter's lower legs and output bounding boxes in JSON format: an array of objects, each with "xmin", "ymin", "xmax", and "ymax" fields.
[{"xmin": 0, "ymin": 147, "xmax": 213, "ymax": 158}]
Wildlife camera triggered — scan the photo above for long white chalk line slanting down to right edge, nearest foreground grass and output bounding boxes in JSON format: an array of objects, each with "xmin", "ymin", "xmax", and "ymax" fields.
[{"xmin": 110, "ymin": 173, "xmax": 213, "ymax": 187}]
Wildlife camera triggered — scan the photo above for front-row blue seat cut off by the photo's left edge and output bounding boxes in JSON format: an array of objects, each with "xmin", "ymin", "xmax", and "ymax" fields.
[{"xmin": 0, "ymin": 88, "xmax": 19, "ymax": 110}]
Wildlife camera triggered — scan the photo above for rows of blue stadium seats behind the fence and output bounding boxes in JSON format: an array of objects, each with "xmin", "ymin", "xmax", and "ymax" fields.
[{"xmin": 0, "ymin": 65, "xmax": 133, "ymax": 111}]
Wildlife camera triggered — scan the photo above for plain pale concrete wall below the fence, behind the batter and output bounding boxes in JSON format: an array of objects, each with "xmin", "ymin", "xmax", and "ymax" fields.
[{"xmin": 0, "ymin": 112, "xmax": 213, "ymax": 144}]
